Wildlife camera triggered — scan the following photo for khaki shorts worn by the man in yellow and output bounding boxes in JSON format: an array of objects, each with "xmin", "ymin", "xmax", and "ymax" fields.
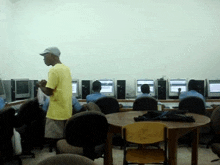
[{"xmin": 45, "ymin": 118, "xmax": 67, "ymax": 139}]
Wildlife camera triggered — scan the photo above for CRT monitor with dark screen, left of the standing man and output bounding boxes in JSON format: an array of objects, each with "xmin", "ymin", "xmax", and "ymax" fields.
[{"xmin": 14, "ymin": 79, "xmax": 30, "ymax": 99}]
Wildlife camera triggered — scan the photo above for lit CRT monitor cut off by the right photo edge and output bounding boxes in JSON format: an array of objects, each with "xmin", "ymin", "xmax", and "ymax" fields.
[{"xmin": 207, "ymin": 80, "xmax": 220, "ymax": 98}]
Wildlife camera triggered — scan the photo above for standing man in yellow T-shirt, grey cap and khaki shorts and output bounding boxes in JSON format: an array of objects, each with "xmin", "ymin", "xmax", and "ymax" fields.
[{"xmin": 38, "ymin": 47, "xmax": 72, "ymax": 151}]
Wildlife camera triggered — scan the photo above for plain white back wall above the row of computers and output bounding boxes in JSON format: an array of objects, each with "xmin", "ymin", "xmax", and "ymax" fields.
[{"xmin": 3, "ymin": 0, "xmax": 220, "ymax": 92}]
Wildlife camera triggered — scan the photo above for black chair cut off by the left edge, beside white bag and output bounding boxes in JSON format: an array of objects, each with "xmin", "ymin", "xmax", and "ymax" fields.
[{"xmin": 0, "ymin": 108, "xmax": 22, "ymax": 165}]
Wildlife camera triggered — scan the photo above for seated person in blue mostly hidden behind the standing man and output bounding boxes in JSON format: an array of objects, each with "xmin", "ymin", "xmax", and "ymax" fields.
[{"xmin": 42, "ymin": 96, "xmax": 83, "ymax": 114}]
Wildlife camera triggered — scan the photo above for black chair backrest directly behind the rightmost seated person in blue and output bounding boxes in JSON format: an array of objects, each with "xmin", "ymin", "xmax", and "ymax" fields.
[{"xmin": 179, "ymin": 96, "xmax": 206, "ymax": 115}]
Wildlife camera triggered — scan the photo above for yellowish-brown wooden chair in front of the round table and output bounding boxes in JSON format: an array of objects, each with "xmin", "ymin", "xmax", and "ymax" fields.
[{"xmin": 123, "ymin": 122, "xmax": 167, "ymax": 165}]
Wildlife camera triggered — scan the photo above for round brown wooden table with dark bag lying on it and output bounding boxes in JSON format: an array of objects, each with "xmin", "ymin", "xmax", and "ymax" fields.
[{"xmin": 104, "ymin": 111, "xmax": 210, "ymax": 165}]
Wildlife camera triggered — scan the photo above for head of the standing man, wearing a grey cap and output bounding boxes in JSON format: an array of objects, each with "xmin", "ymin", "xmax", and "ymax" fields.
[{"xmin": 40, "ymin": 47, "xmax": 61, "ymax": 66}]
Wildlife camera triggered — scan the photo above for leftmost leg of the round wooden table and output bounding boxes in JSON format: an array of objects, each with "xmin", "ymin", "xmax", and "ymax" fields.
[{"xmin": 104, "ymin": 132, "xmax": 113, "ymax": 165}]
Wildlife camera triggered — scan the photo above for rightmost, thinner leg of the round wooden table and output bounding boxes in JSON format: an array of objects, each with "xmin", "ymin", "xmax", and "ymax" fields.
[{"xmin": 192, "ymin": 128, "xmax": 200, "ymax": 165}]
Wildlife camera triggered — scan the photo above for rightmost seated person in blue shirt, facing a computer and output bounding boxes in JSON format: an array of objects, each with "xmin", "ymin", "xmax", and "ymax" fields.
[{"xmin": 179, "ymin": 79, "xmax": 205, "ymax": 104}]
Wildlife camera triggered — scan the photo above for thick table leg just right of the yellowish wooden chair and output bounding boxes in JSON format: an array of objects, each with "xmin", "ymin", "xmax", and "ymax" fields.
[{"xmin": 168, "ymin": 130, "xmax": 178, "ymax": 165}]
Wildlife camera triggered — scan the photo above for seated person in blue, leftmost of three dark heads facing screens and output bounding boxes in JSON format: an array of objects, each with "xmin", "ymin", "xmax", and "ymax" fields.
[{"xmin": 86, "ymin": 80, "xmax": 105, "ymax": 103}]
